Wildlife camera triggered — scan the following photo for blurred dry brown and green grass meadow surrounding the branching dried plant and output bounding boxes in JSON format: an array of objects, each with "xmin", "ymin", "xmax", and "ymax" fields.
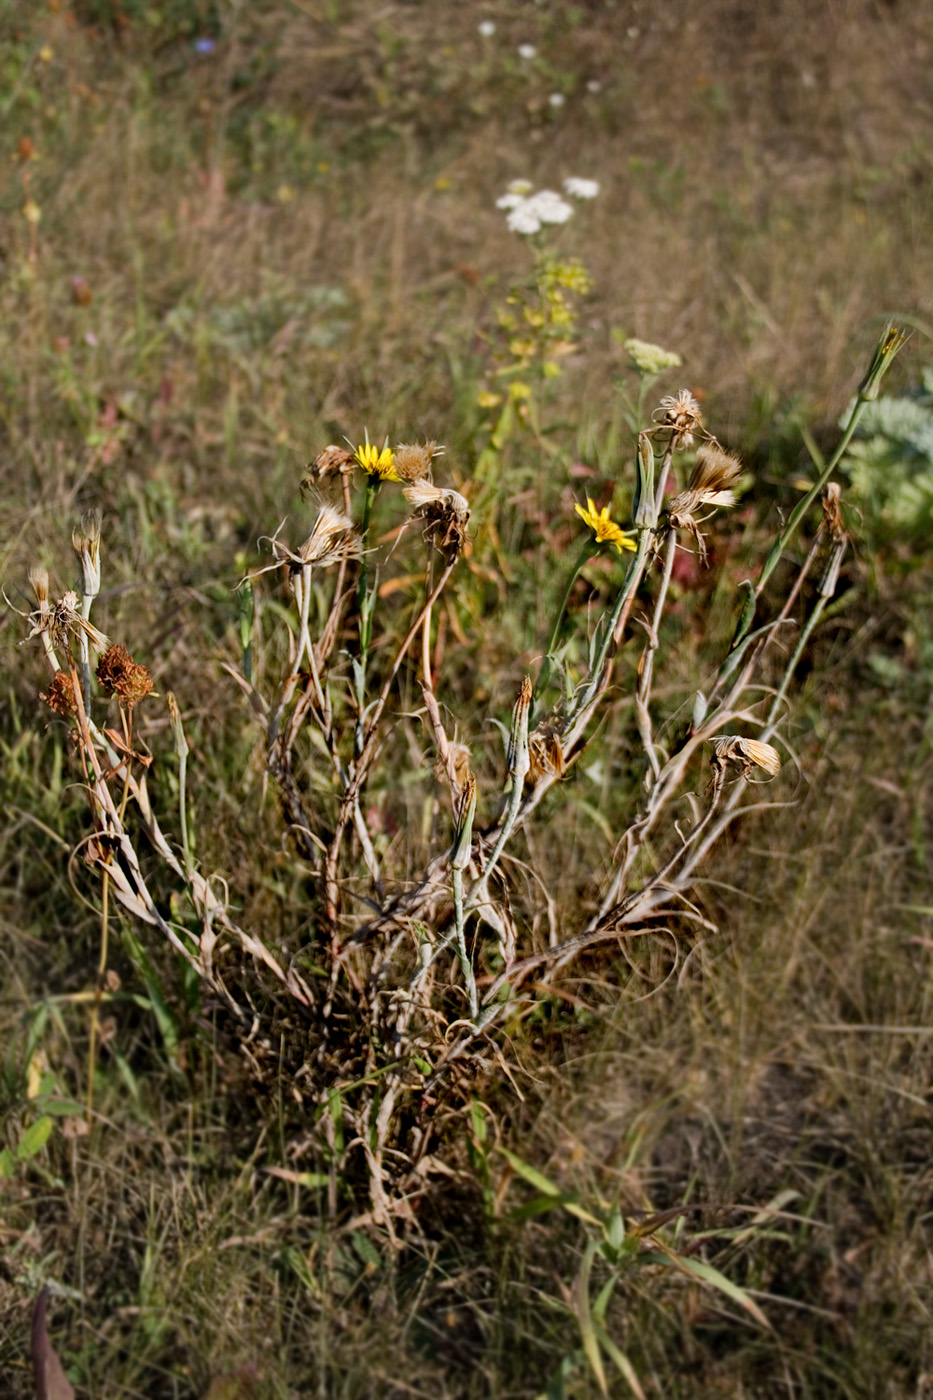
[{"xmin": 0, "ymin": 0, "xmax": 933, "ymax": 1400}]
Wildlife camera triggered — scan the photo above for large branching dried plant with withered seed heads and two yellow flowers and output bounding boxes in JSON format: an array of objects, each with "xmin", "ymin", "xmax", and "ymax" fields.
[{"xmin": 21, "ymin": 320, "xmax": 898, "ymax": 1231}]
